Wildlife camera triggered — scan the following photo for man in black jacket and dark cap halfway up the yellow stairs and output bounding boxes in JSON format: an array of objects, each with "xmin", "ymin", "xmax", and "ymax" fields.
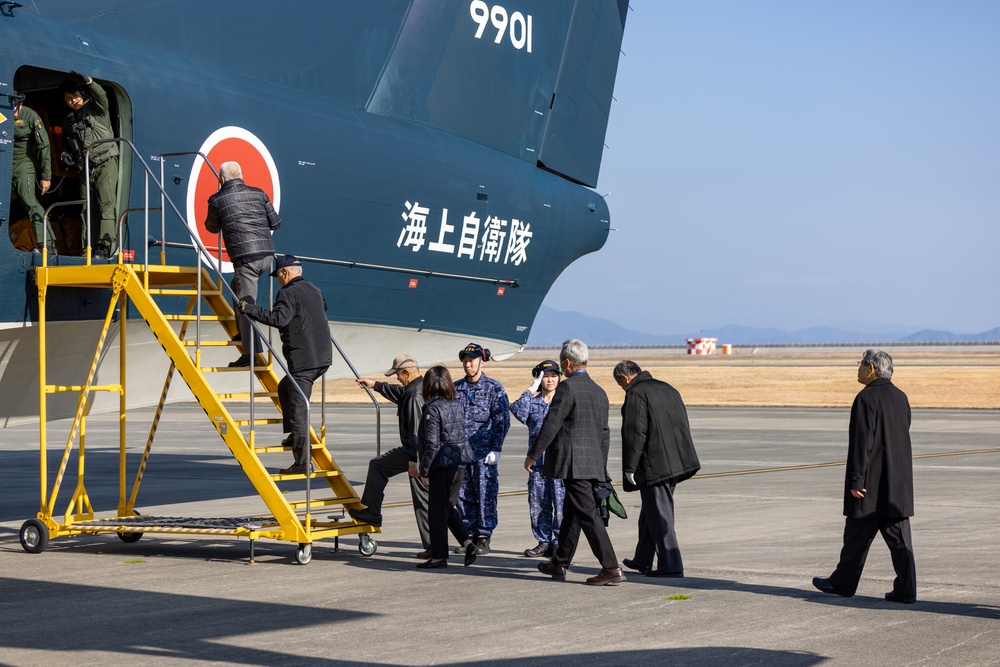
[{"xmin": 238, "ymin": 255, "xmax": 333, "ymax": 475}]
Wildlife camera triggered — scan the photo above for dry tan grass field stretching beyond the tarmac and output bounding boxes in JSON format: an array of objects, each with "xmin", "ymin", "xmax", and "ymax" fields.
[{"xmin": 327, "ymin": 348, "xmax": 1000, "ymax": 410}]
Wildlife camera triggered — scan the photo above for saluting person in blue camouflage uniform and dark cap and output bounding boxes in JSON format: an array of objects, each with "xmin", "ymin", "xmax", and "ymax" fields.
[{"xmin": 510, "ymin": 359, "xmax": 566, "ymax": 558}]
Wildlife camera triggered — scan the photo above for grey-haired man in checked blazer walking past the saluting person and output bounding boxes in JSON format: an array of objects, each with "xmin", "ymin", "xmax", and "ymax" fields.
[{"xmin": 524, "ymin": 339, "xmax": 625, "ymax": 586}]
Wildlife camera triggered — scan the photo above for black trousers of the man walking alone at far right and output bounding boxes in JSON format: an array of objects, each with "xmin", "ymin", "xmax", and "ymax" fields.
[{"xmin": 830, "ymin": 516, "xmax": 917, "ymax": 597}]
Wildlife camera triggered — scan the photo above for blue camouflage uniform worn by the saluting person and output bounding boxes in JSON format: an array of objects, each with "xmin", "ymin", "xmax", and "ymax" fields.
[{"xmin": 510, "ymin": 390, "xmax": 566, "ymax": 549}]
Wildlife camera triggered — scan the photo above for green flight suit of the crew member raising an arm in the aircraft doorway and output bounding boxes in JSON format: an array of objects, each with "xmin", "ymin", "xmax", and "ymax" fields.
[{"xmin": 64, "ymin": 82, "xmax": 118, "ymax": 251}]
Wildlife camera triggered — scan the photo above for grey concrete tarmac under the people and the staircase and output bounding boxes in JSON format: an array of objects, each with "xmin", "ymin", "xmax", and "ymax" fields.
[{"xmin": 0, "ymin": 405, "xmax": 1000, "ymax": 667}]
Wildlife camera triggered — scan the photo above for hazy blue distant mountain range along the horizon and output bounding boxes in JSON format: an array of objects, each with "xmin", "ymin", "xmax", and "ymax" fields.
[{"xmin": 528, "ymin": 306, "xmax": 1000, "ymax": 347}]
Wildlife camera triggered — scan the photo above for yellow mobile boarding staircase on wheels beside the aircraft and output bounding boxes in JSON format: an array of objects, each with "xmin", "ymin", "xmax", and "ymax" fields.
[{"xmin": 20, "ymin": 140, "xmax": 381, "ymax": 565}]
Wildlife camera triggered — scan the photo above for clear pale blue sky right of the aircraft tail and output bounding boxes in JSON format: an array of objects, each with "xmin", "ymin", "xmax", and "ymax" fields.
[{"xmin": 546, "ymin": 0, "xmax": 1000, "ymax": 333}]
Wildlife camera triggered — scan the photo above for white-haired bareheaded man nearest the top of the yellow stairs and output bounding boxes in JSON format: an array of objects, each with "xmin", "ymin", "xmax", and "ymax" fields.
[{"xmin": 205, "ymin": 162, "xmax": 281, "ymax": 366}]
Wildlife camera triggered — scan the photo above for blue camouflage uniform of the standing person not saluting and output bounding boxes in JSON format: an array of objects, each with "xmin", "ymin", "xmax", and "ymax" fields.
[{"xmin": 455, "ymin": 375, "xmax": 510, "ymax": 537}]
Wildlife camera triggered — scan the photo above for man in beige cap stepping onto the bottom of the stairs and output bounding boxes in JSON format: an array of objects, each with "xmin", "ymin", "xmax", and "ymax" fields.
[{"xmin": 347, "ymin": 354, "xmax": 431, "ymax": 559}]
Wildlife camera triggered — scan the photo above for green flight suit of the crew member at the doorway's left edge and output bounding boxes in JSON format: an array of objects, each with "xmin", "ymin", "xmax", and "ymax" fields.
[{"xmin": 11, "ymin": 106, "xmax": 55, "ymax": 246}]
